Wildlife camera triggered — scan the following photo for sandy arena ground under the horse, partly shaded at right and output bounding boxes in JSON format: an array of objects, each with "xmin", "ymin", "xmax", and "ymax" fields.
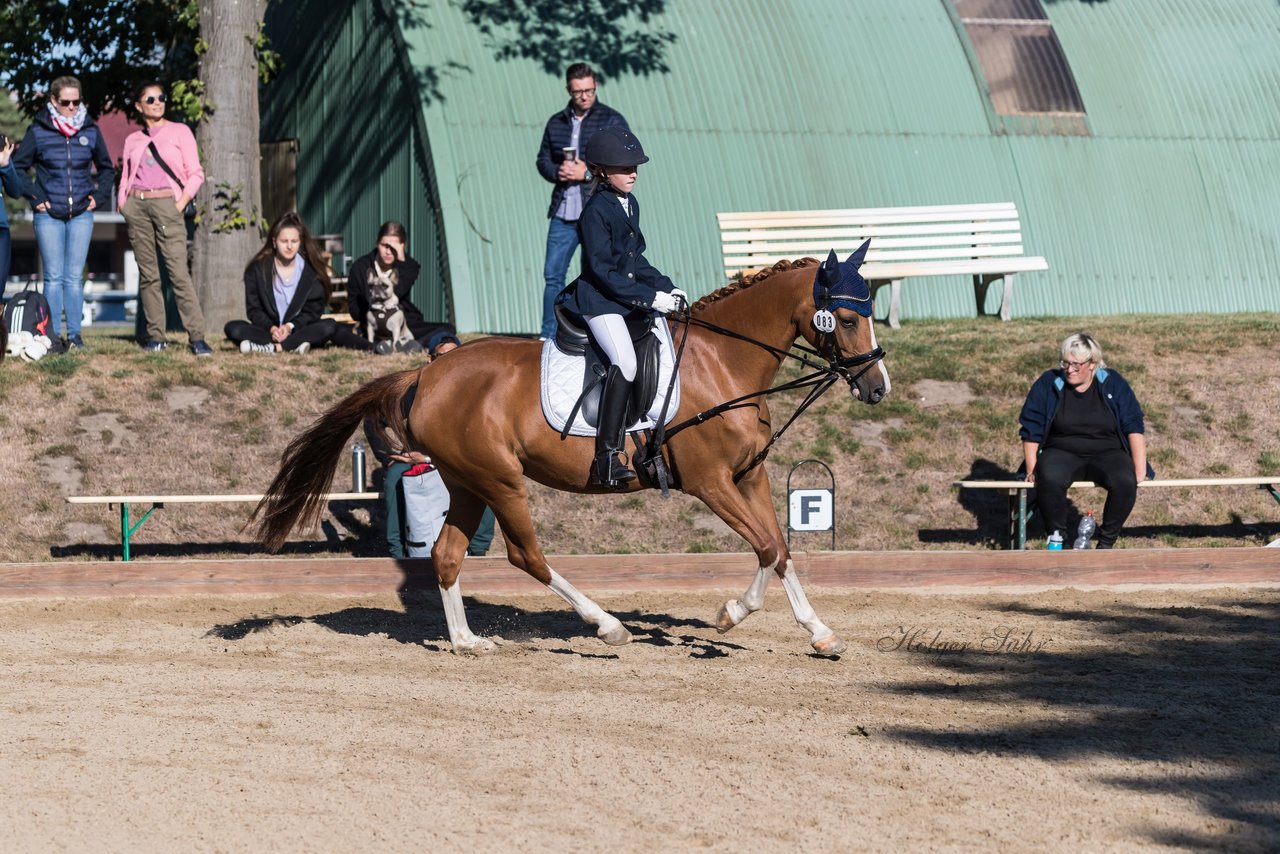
[{"xmin": 0, "ymin": 585, "xmax": 1280, "ymax": 851}]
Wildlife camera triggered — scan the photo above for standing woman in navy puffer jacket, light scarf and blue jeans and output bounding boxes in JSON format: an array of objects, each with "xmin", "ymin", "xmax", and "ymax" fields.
[{"xmin": 13, "ymin": 77, "xmax": 115, "ymax": 352}]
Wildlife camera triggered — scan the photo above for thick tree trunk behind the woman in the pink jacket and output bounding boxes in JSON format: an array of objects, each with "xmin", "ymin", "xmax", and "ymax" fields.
[{"xmin": 195, "ymin": 0, "xmax": 266, "ymax": 334}]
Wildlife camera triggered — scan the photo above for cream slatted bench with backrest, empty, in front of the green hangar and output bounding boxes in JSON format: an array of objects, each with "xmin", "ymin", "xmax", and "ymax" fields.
[{"xmin": 716, "ymin": 202, "xmax": 1048, "ymax": 328}]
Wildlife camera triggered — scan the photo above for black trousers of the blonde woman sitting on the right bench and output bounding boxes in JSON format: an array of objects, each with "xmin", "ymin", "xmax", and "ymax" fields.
[{"xmin": 1036, "ymin": 448, "xmax": 1138, "ymax": 548}]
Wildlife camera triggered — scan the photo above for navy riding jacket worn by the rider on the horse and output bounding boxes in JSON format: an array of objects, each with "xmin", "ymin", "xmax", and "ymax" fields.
[{"xmin": 563, "ymin": 189, "xmax": 675, "ymax": 316}]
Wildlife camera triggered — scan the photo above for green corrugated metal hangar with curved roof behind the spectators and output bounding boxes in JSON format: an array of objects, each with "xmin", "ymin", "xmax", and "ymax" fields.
[{"xmin": 261, "ymin": 0, "xmax": 1280, "ymax": 334}]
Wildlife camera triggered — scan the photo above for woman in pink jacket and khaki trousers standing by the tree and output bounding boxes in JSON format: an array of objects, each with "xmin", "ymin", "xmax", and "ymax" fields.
[{"xmin": 119, "ymin": 82, "xmax": 214, "ymax": 356}]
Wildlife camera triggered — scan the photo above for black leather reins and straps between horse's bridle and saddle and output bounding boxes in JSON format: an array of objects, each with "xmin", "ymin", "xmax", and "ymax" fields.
[{"xmin": 645, "ymin": 306, "xmax": 884, "ymax": 483}]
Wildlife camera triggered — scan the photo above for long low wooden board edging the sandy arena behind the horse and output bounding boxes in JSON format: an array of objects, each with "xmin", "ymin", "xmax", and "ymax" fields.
[{"xmin": 0, "ymin": 548, "xmax": 1280, "ymax": 599}]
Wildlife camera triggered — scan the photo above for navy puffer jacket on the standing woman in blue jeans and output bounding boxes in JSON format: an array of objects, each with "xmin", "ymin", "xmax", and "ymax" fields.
[{"xmin": 13, "ymin": 111, "xmax": 115, "ymax": 220}]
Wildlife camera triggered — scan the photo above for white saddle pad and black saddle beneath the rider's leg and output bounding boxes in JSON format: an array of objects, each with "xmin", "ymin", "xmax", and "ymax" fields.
[{"xmin": 541, "ymin": 305, "xmax": 680, "ymax": 437}]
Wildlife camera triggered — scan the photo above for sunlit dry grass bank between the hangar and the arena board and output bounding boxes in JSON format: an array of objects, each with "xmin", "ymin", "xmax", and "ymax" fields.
[{"xmin": 0, "ymin": 314, "xmax": 1280, "ymax": 561}]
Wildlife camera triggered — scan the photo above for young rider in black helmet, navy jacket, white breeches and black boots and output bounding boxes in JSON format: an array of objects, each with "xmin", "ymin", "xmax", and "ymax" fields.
[{"xmin": 561, "ymin": 127, "xmax": 689, "ymax": 489}]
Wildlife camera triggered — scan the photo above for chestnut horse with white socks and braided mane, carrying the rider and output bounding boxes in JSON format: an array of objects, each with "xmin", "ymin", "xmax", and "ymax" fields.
[{"xmin": 250, "ymin": 257, "xmax": 890, "ymax": 656}]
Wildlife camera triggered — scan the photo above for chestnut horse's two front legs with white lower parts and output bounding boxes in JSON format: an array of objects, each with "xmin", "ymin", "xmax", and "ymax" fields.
[{"xmin": 699, "ymin": 467, "xmax": 845, "ymax": 656}]
